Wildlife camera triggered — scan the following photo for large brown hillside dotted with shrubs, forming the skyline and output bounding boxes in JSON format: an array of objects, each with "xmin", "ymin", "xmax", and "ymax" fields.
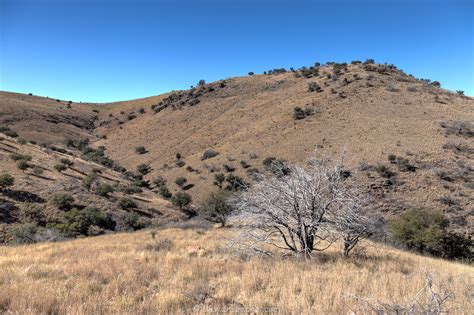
[{"xmin": 0, "ymin": 62, "xmax": 474, "ymax": 239}]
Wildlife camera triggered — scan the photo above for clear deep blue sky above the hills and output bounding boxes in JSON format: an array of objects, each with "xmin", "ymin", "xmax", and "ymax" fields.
[{"xmin": 0, "ymin": 0, "xmax": 474, "ymax": 102}]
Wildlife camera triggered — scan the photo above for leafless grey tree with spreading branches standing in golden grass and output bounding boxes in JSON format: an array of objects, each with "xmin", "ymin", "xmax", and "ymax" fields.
[{"xmin": 231, "ymin": 160, "xmax": 368, "ymax": 256}]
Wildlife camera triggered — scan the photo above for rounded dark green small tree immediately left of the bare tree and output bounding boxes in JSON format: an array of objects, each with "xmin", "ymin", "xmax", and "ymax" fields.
[{"xmin": 199, "ymin": 190, "xmax": 235, "ymax": 227}]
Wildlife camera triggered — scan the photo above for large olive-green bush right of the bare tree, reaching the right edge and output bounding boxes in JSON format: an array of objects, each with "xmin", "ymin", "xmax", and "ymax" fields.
[{"xmin": 389, "ymin": 209, "xmax": 474, "ymax": 259}]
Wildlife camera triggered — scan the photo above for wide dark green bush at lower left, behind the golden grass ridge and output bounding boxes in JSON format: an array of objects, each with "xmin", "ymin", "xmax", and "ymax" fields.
[{"xmin": 54, "ymin": 207, "xmax": 115, "ymax": 237}]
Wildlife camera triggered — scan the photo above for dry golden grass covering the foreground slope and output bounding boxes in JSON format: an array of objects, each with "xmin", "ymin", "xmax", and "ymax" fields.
[{"xmin": 0, "ymin": 228, "xmax": 474, "ymax": 314}]
